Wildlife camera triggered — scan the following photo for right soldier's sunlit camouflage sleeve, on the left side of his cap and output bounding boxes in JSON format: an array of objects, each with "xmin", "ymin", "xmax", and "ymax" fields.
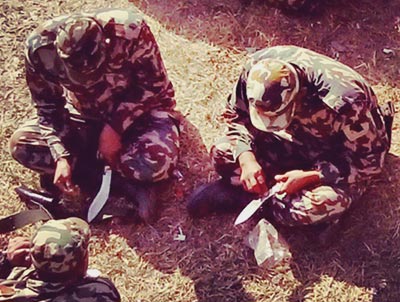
[{"xmin": 222, "ymin": 71, "xmax": 253, "ymax": 161}]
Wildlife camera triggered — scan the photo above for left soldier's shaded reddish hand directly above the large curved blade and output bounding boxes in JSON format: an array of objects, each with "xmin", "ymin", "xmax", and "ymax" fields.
[{"xmin": 99, "ymin": 124, "xmax": 122, "ymax": 170}]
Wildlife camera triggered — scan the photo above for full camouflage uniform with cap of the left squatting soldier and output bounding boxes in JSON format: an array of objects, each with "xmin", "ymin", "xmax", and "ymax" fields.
[{"xmin": 10, "ymin": 9, "xmax": 179, "ymax": 182}]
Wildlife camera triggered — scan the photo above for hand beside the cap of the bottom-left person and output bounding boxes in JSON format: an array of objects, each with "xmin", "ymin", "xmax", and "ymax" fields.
[{"xmin": 7, "ymin": 237, "xmax": 31, "ymax": 267}]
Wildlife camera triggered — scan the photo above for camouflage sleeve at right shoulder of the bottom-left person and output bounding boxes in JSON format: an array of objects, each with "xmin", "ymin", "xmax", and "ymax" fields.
[{"xmin": 51, "ymin": 277, "xmax": 121, "ymax": 302}]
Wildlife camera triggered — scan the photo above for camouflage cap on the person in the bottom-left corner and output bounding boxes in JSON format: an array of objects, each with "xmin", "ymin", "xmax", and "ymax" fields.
[{"xmin": 31, "ymin": 217, "xmax": 90, "ymax": 275}]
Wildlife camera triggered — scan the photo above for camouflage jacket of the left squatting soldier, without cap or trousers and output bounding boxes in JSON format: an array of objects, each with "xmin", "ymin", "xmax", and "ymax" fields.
[{"xmin": 25, "ymin": 9, "xmax": 175, "ymax": 159}]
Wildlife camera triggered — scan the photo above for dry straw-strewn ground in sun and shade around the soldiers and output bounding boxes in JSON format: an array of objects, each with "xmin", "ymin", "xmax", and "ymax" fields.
[{"xmin": 0, "ymin": 0, "xmax": 400, "ymax": 302}]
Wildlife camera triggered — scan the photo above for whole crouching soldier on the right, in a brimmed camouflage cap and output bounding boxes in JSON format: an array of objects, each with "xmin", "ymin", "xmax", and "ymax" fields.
[{"xmin": 188, "ymin": 46, "xmax": 389, "ymax": 226}]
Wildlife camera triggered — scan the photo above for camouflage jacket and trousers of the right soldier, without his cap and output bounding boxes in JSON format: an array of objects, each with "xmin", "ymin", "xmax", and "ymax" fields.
[{"xmin": 211, "ymin": 46, "xmax": 389, "ymax": 225}]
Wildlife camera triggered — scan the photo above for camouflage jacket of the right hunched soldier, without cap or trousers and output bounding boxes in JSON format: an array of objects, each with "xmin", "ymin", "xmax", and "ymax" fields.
[{"xmin": 223, "ymin": 46, "xmax": 389, "ymax": 184}]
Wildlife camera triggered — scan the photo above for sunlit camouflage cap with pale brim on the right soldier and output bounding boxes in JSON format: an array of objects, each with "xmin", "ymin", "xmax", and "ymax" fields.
[{"xmin": 246, "ymin": 59, "xmax": 299, "ymax": 132}]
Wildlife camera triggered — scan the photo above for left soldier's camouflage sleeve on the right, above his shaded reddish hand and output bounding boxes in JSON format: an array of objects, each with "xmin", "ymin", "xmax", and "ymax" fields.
[{"xmin": 109, "ymin": 22, "xmax": 175, "ymax": 133}]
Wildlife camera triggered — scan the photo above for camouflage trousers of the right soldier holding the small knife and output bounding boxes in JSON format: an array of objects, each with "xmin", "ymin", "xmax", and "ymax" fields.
[{"xmin": 211, "ymin": 134, "xmax": 366, "ymax": 226}]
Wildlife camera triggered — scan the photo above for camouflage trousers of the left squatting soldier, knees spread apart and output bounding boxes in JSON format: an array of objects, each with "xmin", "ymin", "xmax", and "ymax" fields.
[{"xmin": 10, "ymin": 111, "xmax": 179, "ymax": 182}]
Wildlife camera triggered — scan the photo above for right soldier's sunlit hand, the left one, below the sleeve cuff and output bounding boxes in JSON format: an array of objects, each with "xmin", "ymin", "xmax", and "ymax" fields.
[{"xmin": 239, "ymin": 151, "xmax": 267, "ymax": 195}]
